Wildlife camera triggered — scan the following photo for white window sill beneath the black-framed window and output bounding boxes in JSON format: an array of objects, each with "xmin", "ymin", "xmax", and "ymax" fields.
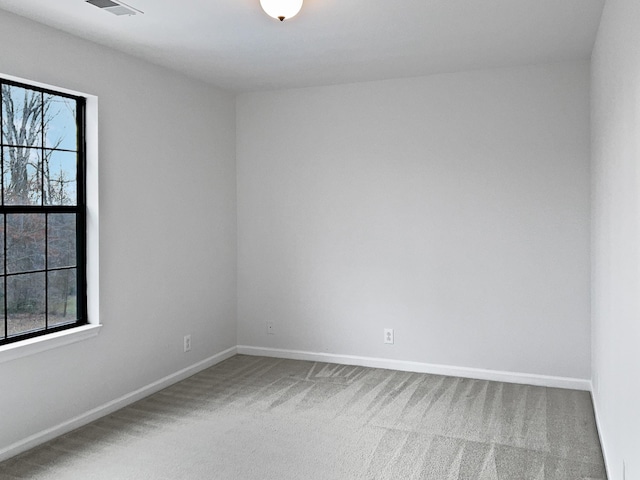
[{"xmin": 0, "ymin": 324, "xmax": 102, "ymax": 363}]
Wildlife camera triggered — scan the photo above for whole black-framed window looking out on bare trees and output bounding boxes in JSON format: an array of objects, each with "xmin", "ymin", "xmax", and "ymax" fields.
[{"xmin": 0, "ymin": 79, "xmax": 87, "ymax": 345}]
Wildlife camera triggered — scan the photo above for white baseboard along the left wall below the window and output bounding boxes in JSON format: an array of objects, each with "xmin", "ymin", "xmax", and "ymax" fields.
[{"xmin": 0, "ymin": 347, "xmax": 237, "ymax": 462}]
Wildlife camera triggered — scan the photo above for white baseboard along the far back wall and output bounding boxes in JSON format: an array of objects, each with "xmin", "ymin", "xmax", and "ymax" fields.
[{"xmin": 238, "ymin": 345, "xmax": 591, "ymax": 391}]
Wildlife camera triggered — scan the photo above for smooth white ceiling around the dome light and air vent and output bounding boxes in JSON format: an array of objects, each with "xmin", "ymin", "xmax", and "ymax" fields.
[{"xmin": 0, "ymin": 0, "xmax": 604, "ymax": 91}]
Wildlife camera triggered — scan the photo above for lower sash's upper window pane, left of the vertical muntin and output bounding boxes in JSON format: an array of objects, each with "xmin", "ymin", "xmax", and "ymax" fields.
[{"xmin": 6, "ymin": 213, "xmax": 45, "ymax": 273}]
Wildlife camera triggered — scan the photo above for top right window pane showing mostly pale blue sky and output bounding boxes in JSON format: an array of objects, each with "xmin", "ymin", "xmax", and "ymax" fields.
[{"xmin": 44, "ymin": 93, "xmax": 78, "ymax": 150}]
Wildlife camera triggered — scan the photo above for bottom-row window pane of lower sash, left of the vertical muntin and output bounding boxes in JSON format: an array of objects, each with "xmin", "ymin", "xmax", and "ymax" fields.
[{"xmin": 6, "ymin": 272, "xmax": 46, "ymax": 336}]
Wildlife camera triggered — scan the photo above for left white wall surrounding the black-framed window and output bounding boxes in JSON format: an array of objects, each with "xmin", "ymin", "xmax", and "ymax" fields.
[{"xmin": 0, "ymin": 12, "xmax": 237, "ymax": 451}]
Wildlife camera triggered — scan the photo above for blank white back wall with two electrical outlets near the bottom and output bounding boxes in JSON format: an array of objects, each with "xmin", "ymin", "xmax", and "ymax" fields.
[{"xmin": 236, "ymin": 62, "xmax": 590, "ymax": 379}]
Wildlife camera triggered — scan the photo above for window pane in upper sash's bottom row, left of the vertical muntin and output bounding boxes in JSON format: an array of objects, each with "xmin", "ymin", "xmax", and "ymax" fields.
[{"xmin": 2, "ymin": 147, "xmax": 42, "ymax": 205}]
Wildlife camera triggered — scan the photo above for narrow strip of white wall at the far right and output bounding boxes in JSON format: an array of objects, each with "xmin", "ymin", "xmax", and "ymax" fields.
[{"xmin": 591, "ymin": 0, "xmax": 640, "ymax": 480}]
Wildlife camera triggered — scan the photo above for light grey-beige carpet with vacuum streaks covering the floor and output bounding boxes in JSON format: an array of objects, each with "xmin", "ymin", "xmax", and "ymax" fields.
[{"xmin": 0, "ymin": 355, "xmax": 606, "ymax": 480}]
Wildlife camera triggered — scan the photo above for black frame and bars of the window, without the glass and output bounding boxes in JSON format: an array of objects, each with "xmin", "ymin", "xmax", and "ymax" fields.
[{"xmin": 0, "ymin": 76, "xmax": 89, "ymax": 346}]
